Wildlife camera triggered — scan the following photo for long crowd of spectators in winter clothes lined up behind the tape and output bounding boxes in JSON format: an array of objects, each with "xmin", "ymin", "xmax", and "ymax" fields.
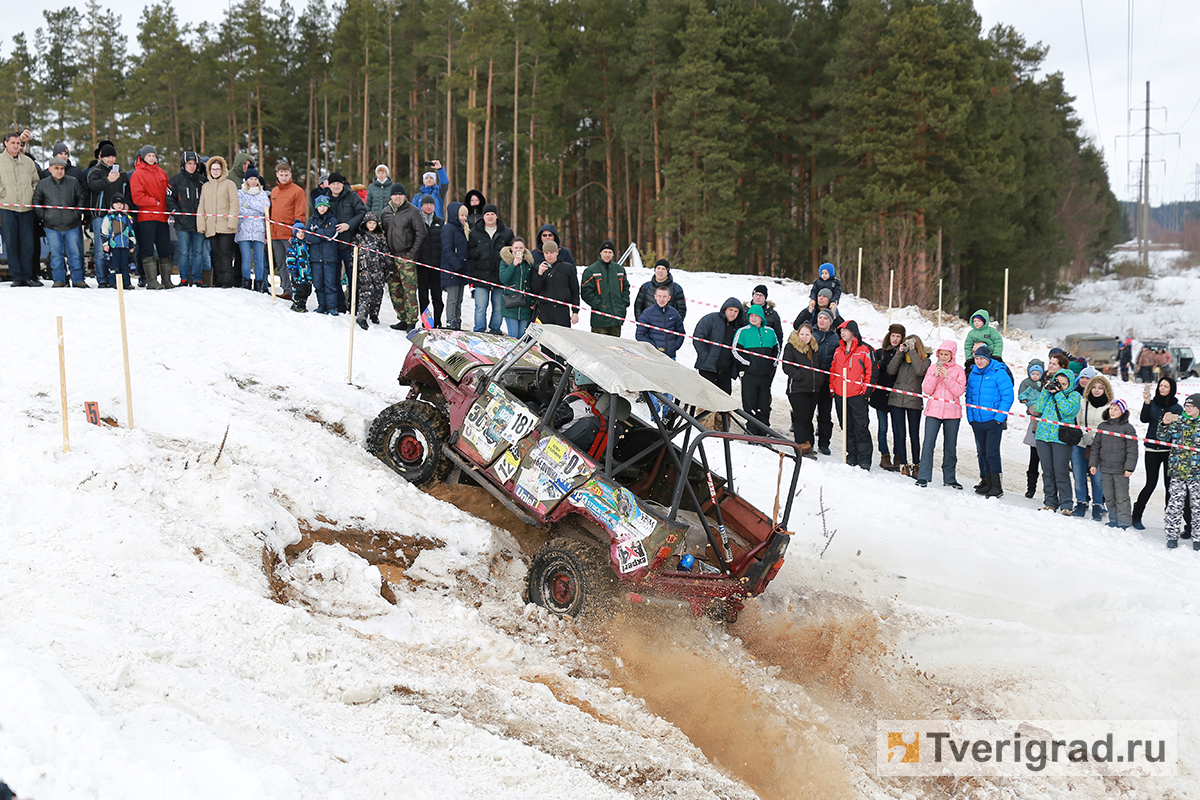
[{"xmin": 0, "ymin": 132, "xmax": 1200, "ymax": 549}]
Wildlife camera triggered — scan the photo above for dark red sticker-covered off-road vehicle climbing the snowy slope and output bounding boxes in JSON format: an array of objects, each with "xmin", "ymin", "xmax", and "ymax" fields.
[{"xmin": 366, "ymin": 323, "xmax": 800, "ymax": 621}]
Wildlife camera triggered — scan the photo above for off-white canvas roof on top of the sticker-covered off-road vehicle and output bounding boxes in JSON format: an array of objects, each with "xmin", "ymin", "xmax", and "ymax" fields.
[{"xmin": 527, "ymin": 323, "xmax": 742, "ymax": 411}]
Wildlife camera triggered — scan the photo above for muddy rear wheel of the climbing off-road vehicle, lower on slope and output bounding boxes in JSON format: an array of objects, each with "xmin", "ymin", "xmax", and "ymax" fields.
[{"xmin": 526, "ymin": 537, "xmax": 617, "ymax": 616}]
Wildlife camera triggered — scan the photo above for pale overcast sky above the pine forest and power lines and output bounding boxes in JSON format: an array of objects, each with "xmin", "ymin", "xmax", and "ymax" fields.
[{"xmin": 9, "ymin": 0, "xmax": 1200, "ymax": 204}]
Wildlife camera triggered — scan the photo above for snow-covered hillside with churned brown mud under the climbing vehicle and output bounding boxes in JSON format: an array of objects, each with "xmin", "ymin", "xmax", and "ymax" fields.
[{"xmin": 0, "ymin": 257, "xmax": 1200, "ymax": 800}]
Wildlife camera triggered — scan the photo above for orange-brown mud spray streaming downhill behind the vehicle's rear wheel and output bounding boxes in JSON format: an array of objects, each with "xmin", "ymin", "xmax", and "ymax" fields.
[{"xmin": 608, "ymin": 612, "xmax": 857, "ymax": 800}]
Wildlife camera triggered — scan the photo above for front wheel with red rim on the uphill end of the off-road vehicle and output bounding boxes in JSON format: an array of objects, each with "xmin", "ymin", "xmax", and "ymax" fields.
[{"xmin": 366, "ymin": 401, "xmax": 451, "ymax": 486}]
